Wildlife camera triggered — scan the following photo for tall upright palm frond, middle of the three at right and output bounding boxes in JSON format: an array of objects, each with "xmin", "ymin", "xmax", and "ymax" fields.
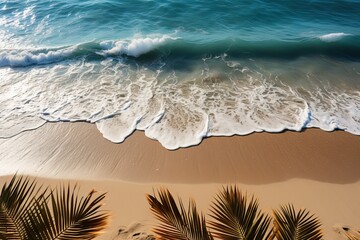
[{"xmin": 209, "ymin": 186, "xmax": 270, "ymax": 240}]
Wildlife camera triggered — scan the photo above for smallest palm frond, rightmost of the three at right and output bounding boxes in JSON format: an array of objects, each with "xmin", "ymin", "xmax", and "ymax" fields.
[{"xmin": 273, "ymin": 204, "xmax": 322, "ymax": 240}]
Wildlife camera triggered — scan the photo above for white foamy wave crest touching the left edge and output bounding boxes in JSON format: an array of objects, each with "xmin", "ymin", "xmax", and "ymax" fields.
[{"xmin": 0, "ymin": 47, "xmax": 76, "ymax": 67}]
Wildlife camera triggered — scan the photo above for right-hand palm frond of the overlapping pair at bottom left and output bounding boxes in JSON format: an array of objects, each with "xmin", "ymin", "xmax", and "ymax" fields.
[{"xmin": 23, "ymin": 186, "xmax": 108, "ymax": 240}]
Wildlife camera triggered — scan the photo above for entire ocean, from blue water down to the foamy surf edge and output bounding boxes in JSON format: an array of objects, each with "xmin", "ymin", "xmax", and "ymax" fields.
[{"xmin": 0, "ymin": 0, "xmax": 360, "ymax": 149}]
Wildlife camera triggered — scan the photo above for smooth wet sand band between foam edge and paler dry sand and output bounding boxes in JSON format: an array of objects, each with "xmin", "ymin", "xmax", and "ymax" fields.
[{"xmin": 0, "ymin": 123, "xmax": 360, "ymax": 184}]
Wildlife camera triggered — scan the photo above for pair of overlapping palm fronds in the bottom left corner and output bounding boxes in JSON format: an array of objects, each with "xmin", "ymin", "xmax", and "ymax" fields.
[{"xmin": 0, "ymin": 176, "xmax": 108, "ymax": 240}]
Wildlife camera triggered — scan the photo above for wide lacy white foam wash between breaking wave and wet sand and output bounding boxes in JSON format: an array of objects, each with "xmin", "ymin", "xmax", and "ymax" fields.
[{"xmin": 0, "ymin": 54, "xmax": 360, "ymax": 149}]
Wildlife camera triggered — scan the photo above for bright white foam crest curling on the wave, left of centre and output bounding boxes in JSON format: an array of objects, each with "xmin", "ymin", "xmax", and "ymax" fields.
[{"xmin": 100, "ymin": 35, "xmax": 175, "ymax": 57}]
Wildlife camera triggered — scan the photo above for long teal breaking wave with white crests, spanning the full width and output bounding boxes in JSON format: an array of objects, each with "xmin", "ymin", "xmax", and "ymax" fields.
[{"xmin": 0, "ymin": 33, "xmax": 360, "ymax": 67}]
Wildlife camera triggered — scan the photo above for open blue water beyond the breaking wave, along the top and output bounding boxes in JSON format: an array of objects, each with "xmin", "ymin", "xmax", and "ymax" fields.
[{"xmin": 0, "ymin": 0, "xmax": 360, "ymax": 46}]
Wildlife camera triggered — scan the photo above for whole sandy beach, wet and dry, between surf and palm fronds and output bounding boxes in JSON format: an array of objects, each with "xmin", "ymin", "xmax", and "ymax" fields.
[{"xmin": 0, "ymin": 123, "xmax": 360, "ymax": 239}]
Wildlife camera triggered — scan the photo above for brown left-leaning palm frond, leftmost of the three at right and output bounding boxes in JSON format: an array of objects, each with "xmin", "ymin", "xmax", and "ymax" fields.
[{"xmin": 147, "ymin": 189, "xmax": 213, "ymax": 240}]
